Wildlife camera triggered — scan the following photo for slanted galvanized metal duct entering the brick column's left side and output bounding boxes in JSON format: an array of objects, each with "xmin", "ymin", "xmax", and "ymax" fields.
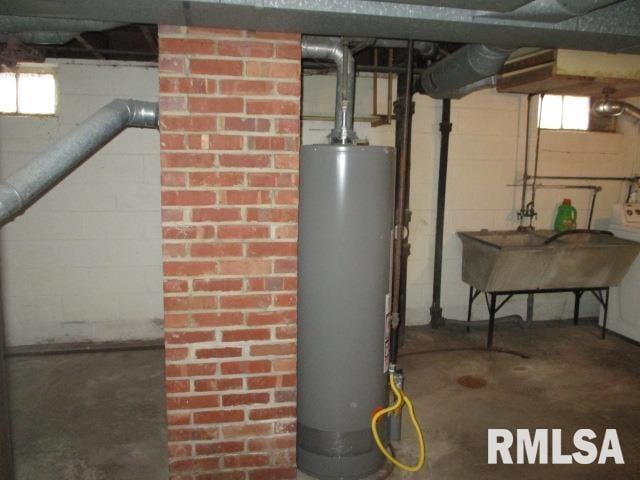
[{"xmin": 0, "ymin": 99, "xmax": 158, "ymax": 226}]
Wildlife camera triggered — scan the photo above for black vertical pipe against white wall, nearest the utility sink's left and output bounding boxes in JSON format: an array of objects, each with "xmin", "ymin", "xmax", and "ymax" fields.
[{"xmin": 430, "ymin": 98, "xmax": 453, "ymax": 328}]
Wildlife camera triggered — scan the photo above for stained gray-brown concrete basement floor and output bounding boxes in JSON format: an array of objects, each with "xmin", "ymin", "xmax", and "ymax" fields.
[{"xmin": 9, "ymin": 323, "xmax": 640, "ymax": 480}]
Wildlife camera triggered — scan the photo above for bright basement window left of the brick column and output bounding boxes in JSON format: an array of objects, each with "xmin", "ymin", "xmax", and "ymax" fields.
[{"xmin": 0, "ymin": 65, "xmax": 58, "ymax": 115}]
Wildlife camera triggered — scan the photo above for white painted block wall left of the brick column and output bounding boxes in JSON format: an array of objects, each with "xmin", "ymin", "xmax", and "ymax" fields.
[{"xmin": 0, "ymin": 60, "xmax": 163, "ymax": 345}]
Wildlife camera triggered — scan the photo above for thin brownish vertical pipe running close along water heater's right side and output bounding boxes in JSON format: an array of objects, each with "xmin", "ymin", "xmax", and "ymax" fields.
[{"xmin": 390, "ymin": 40, "xmax": 413, "ymax": 364}]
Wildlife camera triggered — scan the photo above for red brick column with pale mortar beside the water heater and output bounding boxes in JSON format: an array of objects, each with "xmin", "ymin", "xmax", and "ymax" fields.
[{"xmin": 159, "ymin": 26, "xmax": 300, "ymax": 480}]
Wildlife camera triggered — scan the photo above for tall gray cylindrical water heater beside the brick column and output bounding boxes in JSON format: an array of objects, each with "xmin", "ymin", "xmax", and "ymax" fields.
[{"xmin": 297, "ymin": 145, "xmax": 395, "ymax": 479}]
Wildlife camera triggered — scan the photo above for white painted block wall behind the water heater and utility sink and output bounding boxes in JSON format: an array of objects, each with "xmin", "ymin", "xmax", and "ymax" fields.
[{"xmin": 302, "ymin": 76, "xmax": 640, "ymax": 324}]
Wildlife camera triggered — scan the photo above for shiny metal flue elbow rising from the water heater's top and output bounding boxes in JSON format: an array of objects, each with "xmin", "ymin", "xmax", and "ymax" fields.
[{"xmin": 302, "ymin": 36, "xmax": 356, "ymax": 145}]
